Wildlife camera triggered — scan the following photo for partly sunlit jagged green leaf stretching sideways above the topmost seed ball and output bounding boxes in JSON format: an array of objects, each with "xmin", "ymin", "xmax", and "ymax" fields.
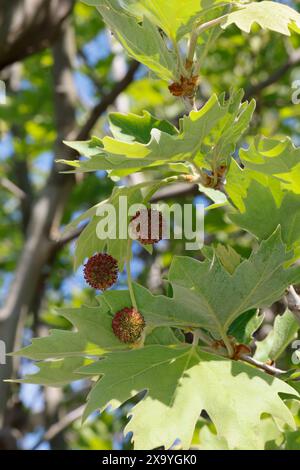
[{"xmin": 62, "ymin": 91, "xmax": 255, "ymax": 179}]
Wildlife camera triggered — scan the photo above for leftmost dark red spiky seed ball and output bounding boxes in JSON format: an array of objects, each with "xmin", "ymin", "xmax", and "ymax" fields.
[{"xmin": 83, "ymin": 253, "xmax": 118, "ymax": 290}]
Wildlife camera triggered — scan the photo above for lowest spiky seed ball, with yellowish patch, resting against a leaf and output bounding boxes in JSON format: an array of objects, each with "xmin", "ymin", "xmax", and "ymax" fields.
[{"xmin": 112, "ymin": 307, "xmax": 145, "ymax": 343}]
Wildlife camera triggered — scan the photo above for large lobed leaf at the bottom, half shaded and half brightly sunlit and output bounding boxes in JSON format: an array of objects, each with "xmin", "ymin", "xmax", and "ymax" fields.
[{"xmin": 79, "ymin": 345, "xmax": 296, "ymax": 449}]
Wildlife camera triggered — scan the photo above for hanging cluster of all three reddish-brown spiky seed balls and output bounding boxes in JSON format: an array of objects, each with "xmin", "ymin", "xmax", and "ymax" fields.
[{"xmin": 83, "ymin": 209, "xmax": 163, "ymax": 344}]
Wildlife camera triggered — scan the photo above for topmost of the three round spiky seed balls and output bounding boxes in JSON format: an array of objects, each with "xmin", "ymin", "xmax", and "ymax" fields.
[{"xmin": 130, "ymin": 209, "xmax": 164, "ymax": 245}]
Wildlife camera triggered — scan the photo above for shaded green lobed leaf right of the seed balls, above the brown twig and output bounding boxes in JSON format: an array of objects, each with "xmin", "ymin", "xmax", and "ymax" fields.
[{"xmin": 169, "ymin": 229, "xmax": 299, "ymax": 336}]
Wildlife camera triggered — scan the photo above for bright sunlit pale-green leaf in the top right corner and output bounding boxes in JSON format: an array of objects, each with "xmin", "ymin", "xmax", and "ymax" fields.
[{"xmin": 222, "ymin": 1, "xmax": 300, "ymax": 36}]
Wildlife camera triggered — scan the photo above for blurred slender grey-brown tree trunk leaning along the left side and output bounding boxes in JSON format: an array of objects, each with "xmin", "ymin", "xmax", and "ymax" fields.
[{"xmin": 0, "ymin": 15, "xmax": 76, "ymax": 424}]
